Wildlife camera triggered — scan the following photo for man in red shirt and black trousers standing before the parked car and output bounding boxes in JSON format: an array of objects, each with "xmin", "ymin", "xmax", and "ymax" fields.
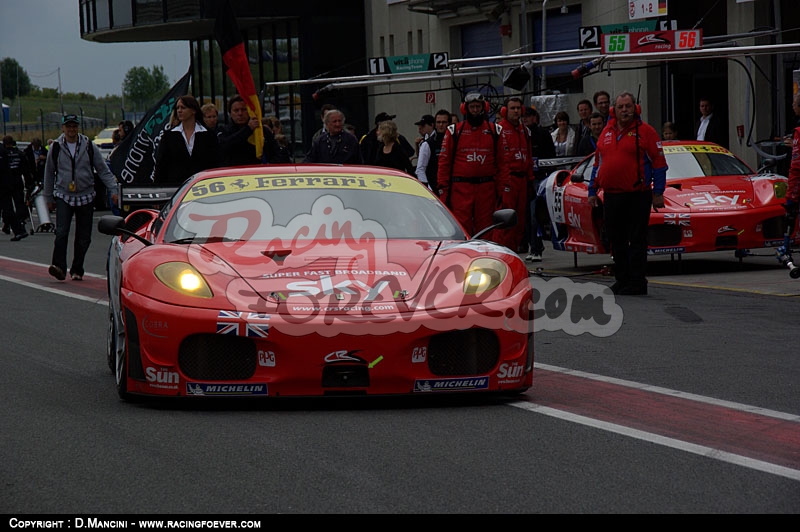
[{"xmin": 589, "ymin": 92, "xmax": 667, "ymax": 295}]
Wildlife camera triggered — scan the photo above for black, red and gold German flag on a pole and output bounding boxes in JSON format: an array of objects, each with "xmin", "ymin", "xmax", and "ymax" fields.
[{"xmin": 214, "ymin": 0, "xmax": 264, "ymax": 159}]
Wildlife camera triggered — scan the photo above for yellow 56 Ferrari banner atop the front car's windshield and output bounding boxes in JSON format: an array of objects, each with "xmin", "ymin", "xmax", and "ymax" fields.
[{"xmin": 183, "ymin": 174, "xmax": 428, "ymax": 202}]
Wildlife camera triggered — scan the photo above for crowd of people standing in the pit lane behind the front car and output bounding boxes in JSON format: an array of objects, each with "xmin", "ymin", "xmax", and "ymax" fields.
[{"xmin": 7, "ymin": 86, "xmax": 780, "ymax": 295}]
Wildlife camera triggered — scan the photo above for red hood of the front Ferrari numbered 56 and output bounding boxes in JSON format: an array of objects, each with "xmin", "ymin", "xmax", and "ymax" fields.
[{"xmin": 204, "ymin": 240, "xmax": 527, "ymax": 314}]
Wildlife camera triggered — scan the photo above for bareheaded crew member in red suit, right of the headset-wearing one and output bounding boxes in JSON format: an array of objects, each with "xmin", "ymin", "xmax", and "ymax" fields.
[{"xmin": 493, "ymin": 96, "xmax": 533, "ymax": 252}]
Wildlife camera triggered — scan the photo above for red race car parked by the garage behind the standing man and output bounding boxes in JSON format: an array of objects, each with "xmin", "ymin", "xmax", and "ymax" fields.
[{"xmin": 536, "ymin": 141, "xmax": 798, "ymax": 257}]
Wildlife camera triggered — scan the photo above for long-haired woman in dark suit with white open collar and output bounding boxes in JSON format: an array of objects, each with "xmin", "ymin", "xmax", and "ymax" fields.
[{"xmin": 153, "ymin": 94, "xmax": 219, "ymax": 185}]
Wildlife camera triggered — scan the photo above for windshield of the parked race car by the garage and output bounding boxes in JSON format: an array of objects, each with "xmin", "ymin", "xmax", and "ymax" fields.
[{"xmin": 664, "ymin": 144, "xmax": 755, "ymax": 180}]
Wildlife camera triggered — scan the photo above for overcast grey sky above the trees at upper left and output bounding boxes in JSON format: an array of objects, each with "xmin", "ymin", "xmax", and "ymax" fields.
[{"xmin": 0, "ymin": 0, "xmax": 189, "ymax": 97}]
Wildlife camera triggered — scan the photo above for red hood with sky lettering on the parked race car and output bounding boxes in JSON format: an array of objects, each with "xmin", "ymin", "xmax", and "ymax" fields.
[{"xmin": 664, "ymin": 176, "xmax": 761, "ymax": 212}]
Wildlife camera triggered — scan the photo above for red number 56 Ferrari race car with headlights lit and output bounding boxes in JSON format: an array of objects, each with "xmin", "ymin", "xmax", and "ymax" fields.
[{"xmin": 98, "ymin": 165, "xmax": 533, "ymax": 398}]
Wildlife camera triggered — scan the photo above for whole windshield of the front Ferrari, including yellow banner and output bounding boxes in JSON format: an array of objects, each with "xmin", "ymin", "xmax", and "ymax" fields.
[{"xmin": 164, "ymin": 174, "xmax": 465, "ymax": 243}]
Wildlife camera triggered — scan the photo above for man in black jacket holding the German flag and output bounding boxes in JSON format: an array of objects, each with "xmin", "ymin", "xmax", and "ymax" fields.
[{"xmin": 217, "ymin": 94, "xmax": 279, "ymax": 166}]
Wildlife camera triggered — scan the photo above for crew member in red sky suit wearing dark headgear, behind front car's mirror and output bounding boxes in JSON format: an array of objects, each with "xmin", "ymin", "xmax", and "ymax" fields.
[{"xmin": 438, "ymin": 92, "xmax": 509, "ymax": 234}]
